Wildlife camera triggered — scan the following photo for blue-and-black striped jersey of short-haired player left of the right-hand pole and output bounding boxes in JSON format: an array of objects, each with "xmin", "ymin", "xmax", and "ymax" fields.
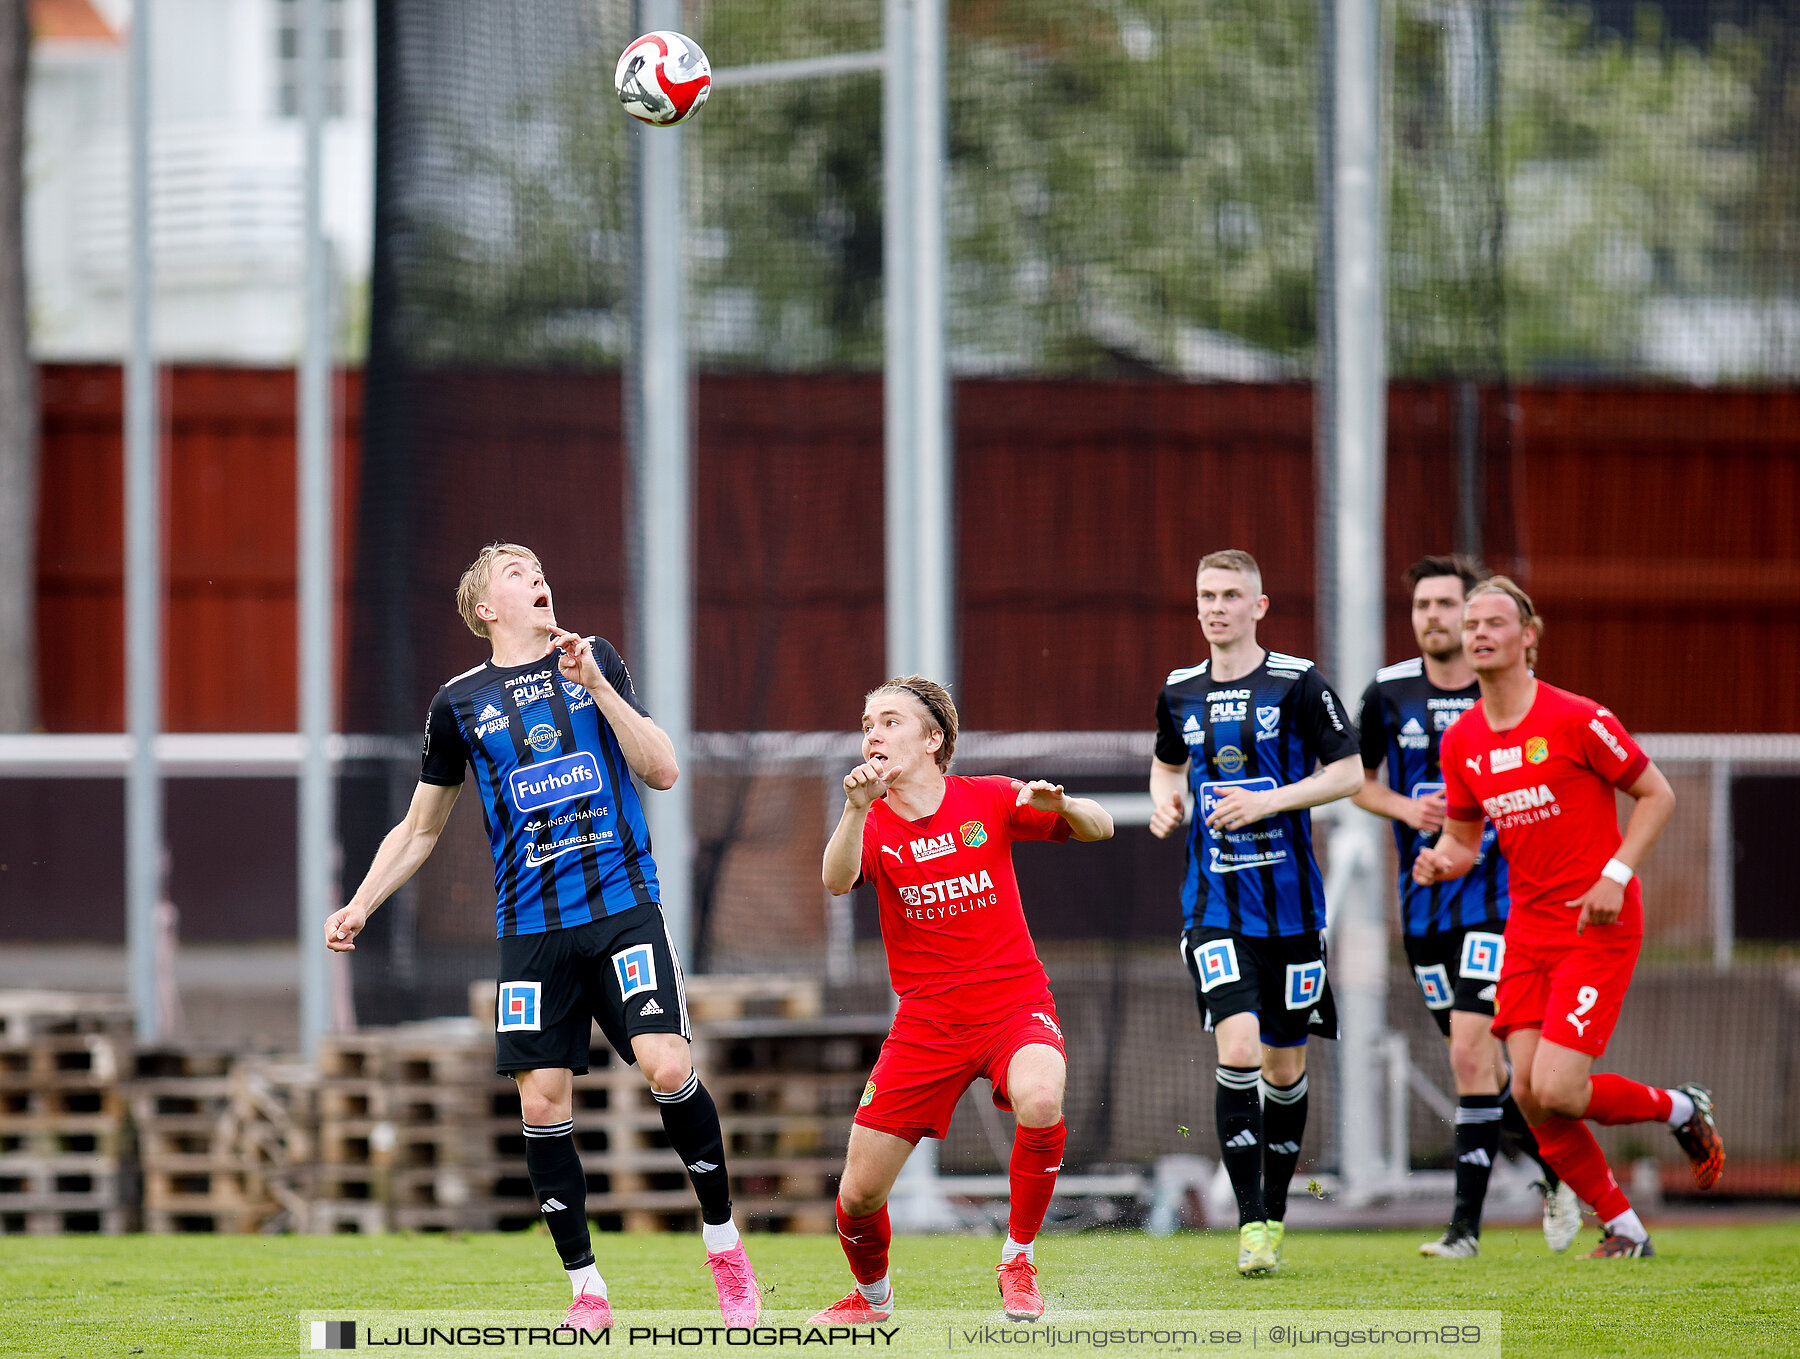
[{"xmin": 1156, "ymin": 652, "xmax": 1355, "ymax": 938}]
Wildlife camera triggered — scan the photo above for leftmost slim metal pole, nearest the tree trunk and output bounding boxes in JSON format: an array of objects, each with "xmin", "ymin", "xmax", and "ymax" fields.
[{"xmin": 124, "ymin": 0, "xmax": 162, "ymax": 1042}]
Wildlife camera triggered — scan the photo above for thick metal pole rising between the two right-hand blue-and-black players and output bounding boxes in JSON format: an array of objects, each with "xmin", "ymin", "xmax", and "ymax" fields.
[{"xmin": 1328, "ymin": 0, "xmax": 1406, "ymax": 1202}]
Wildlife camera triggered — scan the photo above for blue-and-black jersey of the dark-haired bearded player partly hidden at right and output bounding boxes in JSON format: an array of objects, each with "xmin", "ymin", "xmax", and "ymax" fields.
[{"xmin": 1357, "ymin": 655, "xmax": 1510, "ymax": 938}]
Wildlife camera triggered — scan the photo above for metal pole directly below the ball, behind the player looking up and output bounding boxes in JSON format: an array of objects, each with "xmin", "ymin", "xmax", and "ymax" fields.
[{"xmin": 630, "ymin": 0, "xmax": 693, "ymax": 956}]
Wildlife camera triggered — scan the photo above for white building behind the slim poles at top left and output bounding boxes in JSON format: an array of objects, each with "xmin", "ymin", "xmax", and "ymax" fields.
[{"xmin": 25, "ymin": 0, "xmax": 374, "ymax": 364}]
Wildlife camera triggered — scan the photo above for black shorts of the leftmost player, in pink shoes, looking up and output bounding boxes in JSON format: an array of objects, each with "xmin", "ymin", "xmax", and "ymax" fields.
[{"xmin": 493, "ymin": 905, "xmax": 693, "ymax": 1076}]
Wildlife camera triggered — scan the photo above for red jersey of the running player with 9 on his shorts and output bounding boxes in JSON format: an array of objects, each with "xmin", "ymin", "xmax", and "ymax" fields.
[{"xmin": 1438, "ymin": 680, "xmax": 1651, "ymax": 940}]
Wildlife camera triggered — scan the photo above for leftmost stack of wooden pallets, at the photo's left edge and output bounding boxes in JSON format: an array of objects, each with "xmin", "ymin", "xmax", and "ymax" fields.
[{"xmin": 0, "ymin": 992, "xmax": 131, "ymax": 1235}]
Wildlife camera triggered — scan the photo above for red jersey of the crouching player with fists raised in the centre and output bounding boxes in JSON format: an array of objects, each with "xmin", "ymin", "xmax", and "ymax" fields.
[{"xmin": 862, "ymin": 776, "xmax": 1069, "ymax": 1024}]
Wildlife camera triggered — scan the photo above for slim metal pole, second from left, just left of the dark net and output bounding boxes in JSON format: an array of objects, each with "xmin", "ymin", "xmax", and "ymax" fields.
[{"xmin": 295, "ymin": 0, "xmax": 338, "ymax": 1057}]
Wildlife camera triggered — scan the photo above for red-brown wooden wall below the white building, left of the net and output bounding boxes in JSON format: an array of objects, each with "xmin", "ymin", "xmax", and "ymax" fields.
[{"xmin": 38, "ymin": 365, "xmax": 362, "ymax": 731}]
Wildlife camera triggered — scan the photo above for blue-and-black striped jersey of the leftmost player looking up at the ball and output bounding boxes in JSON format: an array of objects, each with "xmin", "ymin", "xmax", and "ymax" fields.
[{"xmin": 419, "ymin": 637, "xmax": 661, "ymax": 938}]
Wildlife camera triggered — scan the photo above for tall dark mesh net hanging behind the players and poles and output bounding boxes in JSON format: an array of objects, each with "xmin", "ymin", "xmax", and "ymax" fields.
[{"xmin": 346, "ymin": 0, "xmax": 1800, "ymax": 1188}]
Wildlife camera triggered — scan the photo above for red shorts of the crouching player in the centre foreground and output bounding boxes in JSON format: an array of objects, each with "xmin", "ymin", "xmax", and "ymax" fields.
[{"xmin": 857, "ymin": 1001, "xmax": 1067, "ymax": 1143}]
